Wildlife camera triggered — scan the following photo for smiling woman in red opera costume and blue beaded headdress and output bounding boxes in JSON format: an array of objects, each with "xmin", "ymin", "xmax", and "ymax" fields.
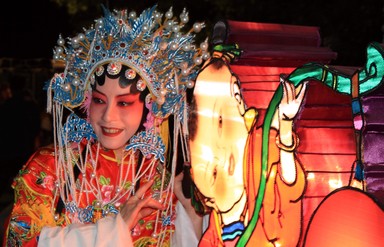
[{"xmin": 4, "ymin": 6, "xmax": 209, "ymax": 247}]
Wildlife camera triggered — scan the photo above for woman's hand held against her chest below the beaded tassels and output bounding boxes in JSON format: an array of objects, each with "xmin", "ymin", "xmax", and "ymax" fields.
[{"xmin": 120, "ymin": 180, "xmax": 165, "ymax": 230}]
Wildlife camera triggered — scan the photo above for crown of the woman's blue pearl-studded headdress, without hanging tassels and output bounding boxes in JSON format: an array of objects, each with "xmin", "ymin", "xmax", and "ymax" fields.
[{"xmin": 51, "ymin": 6, "xmax": 209, "ymax": 118}]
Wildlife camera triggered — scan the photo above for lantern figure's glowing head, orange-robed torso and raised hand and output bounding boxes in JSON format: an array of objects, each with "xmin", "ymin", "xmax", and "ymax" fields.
[{"xmin": 190, "ymin": 53, "xmax": 306, "ymax": 246}]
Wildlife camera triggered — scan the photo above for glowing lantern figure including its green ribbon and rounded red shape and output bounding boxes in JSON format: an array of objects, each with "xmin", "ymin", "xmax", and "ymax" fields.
[{"xmin": 189, "ymin": 43, "xmax": 384, "ymax": 247}]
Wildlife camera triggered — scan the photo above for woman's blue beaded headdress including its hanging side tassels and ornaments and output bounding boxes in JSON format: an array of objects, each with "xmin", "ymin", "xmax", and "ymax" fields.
[{"xmin": 47, "ymin": 3, "xmax": 209, "ymax": 235}]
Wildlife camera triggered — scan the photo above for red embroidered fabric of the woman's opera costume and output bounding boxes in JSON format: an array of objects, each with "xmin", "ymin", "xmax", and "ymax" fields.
[{"xmin": 5, "ymin": 145, "xmax": 176, "ymax": 246}]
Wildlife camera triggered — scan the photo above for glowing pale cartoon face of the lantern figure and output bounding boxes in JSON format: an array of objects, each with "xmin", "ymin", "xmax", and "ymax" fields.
[{"xmin": 190, "ymin": 60, "xmax": 248, "ymax": 218}]
